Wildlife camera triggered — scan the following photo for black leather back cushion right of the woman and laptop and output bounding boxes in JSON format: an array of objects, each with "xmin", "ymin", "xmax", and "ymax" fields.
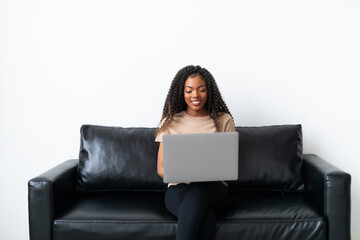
[{"xmin": 229, "ymin": 124, "xmax": 304, "ymax": 191}]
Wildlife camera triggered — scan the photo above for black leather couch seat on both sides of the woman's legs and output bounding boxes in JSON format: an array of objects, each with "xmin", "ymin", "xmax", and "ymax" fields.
[{"xmin": 53, "ymin": 191, "xmax": 325, "ymax": 240}]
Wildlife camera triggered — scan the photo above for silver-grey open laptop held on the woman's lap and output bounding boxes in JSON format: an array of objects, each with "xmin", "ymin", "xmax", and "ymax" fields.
[{"xmin": 163, "ymin": 132, "xmax": 239, "ymax": 183}]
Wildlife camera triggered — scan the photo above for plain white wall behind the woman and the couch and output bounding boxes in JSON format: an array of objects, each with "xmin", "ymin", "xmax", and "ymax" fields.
[{"xmin": 0, "ymin": 0, "xmax": 360, "ymax": 240}]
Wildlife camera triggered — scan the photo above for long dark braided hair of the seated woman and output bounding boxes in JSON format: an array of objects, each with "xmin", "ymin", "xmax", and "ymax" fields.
[{"xmin": 155, "ymin": 65, "xmax": 235, "ymax": 136}]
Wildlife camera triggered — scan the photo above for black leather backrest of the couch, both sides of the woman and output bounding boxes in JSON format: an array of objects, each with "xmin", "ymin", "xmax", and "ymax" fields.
[{"xmin": 76, "ymin": 125, "xmax": 304, "ymax": 192}]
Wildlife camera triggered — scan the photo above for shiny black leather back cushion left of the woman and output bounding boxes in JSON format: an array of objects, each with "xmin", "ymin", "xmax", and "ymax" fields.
[{"xmin": 76, "ymin": 125, "xmax": 166, "ymax": 191}]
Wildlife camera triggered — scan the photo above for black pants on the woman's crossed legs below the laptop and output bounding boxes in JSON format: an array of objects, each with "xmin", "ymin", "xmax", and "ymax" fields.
[{"xmin": 165, "ymin": 182, "xmax": 229, "ymax": 240}]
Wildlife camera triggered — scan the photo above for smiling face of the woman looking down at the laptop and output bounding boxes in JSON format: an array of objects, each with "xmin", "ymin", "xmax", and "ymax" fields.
[{"xmin": 184, "ymin": 75, "xmax": 207, "ymax": 116}]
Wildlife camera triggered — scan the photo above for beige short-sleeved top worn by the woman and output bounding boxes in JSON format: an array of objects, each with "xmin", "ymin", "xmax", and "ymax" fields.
[{"xmin": 155, "ymin": 110, "xmax": 236, "ymax": 187}]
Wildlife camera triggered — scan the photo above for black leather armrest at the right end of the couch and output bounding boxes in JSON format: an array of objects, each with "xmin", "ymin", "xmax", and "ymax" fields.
[{"xmin": 304, "ymin": 154, "xmax": 351, "ymax": 240}]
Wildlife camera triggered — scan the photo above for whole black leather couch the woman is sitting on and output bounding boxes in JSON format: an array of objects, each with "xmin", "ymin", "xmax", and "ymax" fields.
[{"xmin": 28, "ymin": 125, "xmax": 351, "ymax": 240}]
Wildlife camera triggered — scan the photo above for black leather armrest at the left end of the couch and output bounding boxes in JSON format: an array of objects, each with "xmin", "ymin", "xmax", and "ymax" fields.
[{"xmin": 28, "ymin": 159, "xmax": 78, "ymax": 240}]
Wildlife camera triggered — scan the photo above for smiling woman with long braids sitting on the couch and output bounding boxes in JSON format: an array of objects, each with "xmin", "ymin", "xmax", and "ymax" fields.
[{"xmin": 155, "ymin": 65, "xmax": 236, "ymax": 240}]
